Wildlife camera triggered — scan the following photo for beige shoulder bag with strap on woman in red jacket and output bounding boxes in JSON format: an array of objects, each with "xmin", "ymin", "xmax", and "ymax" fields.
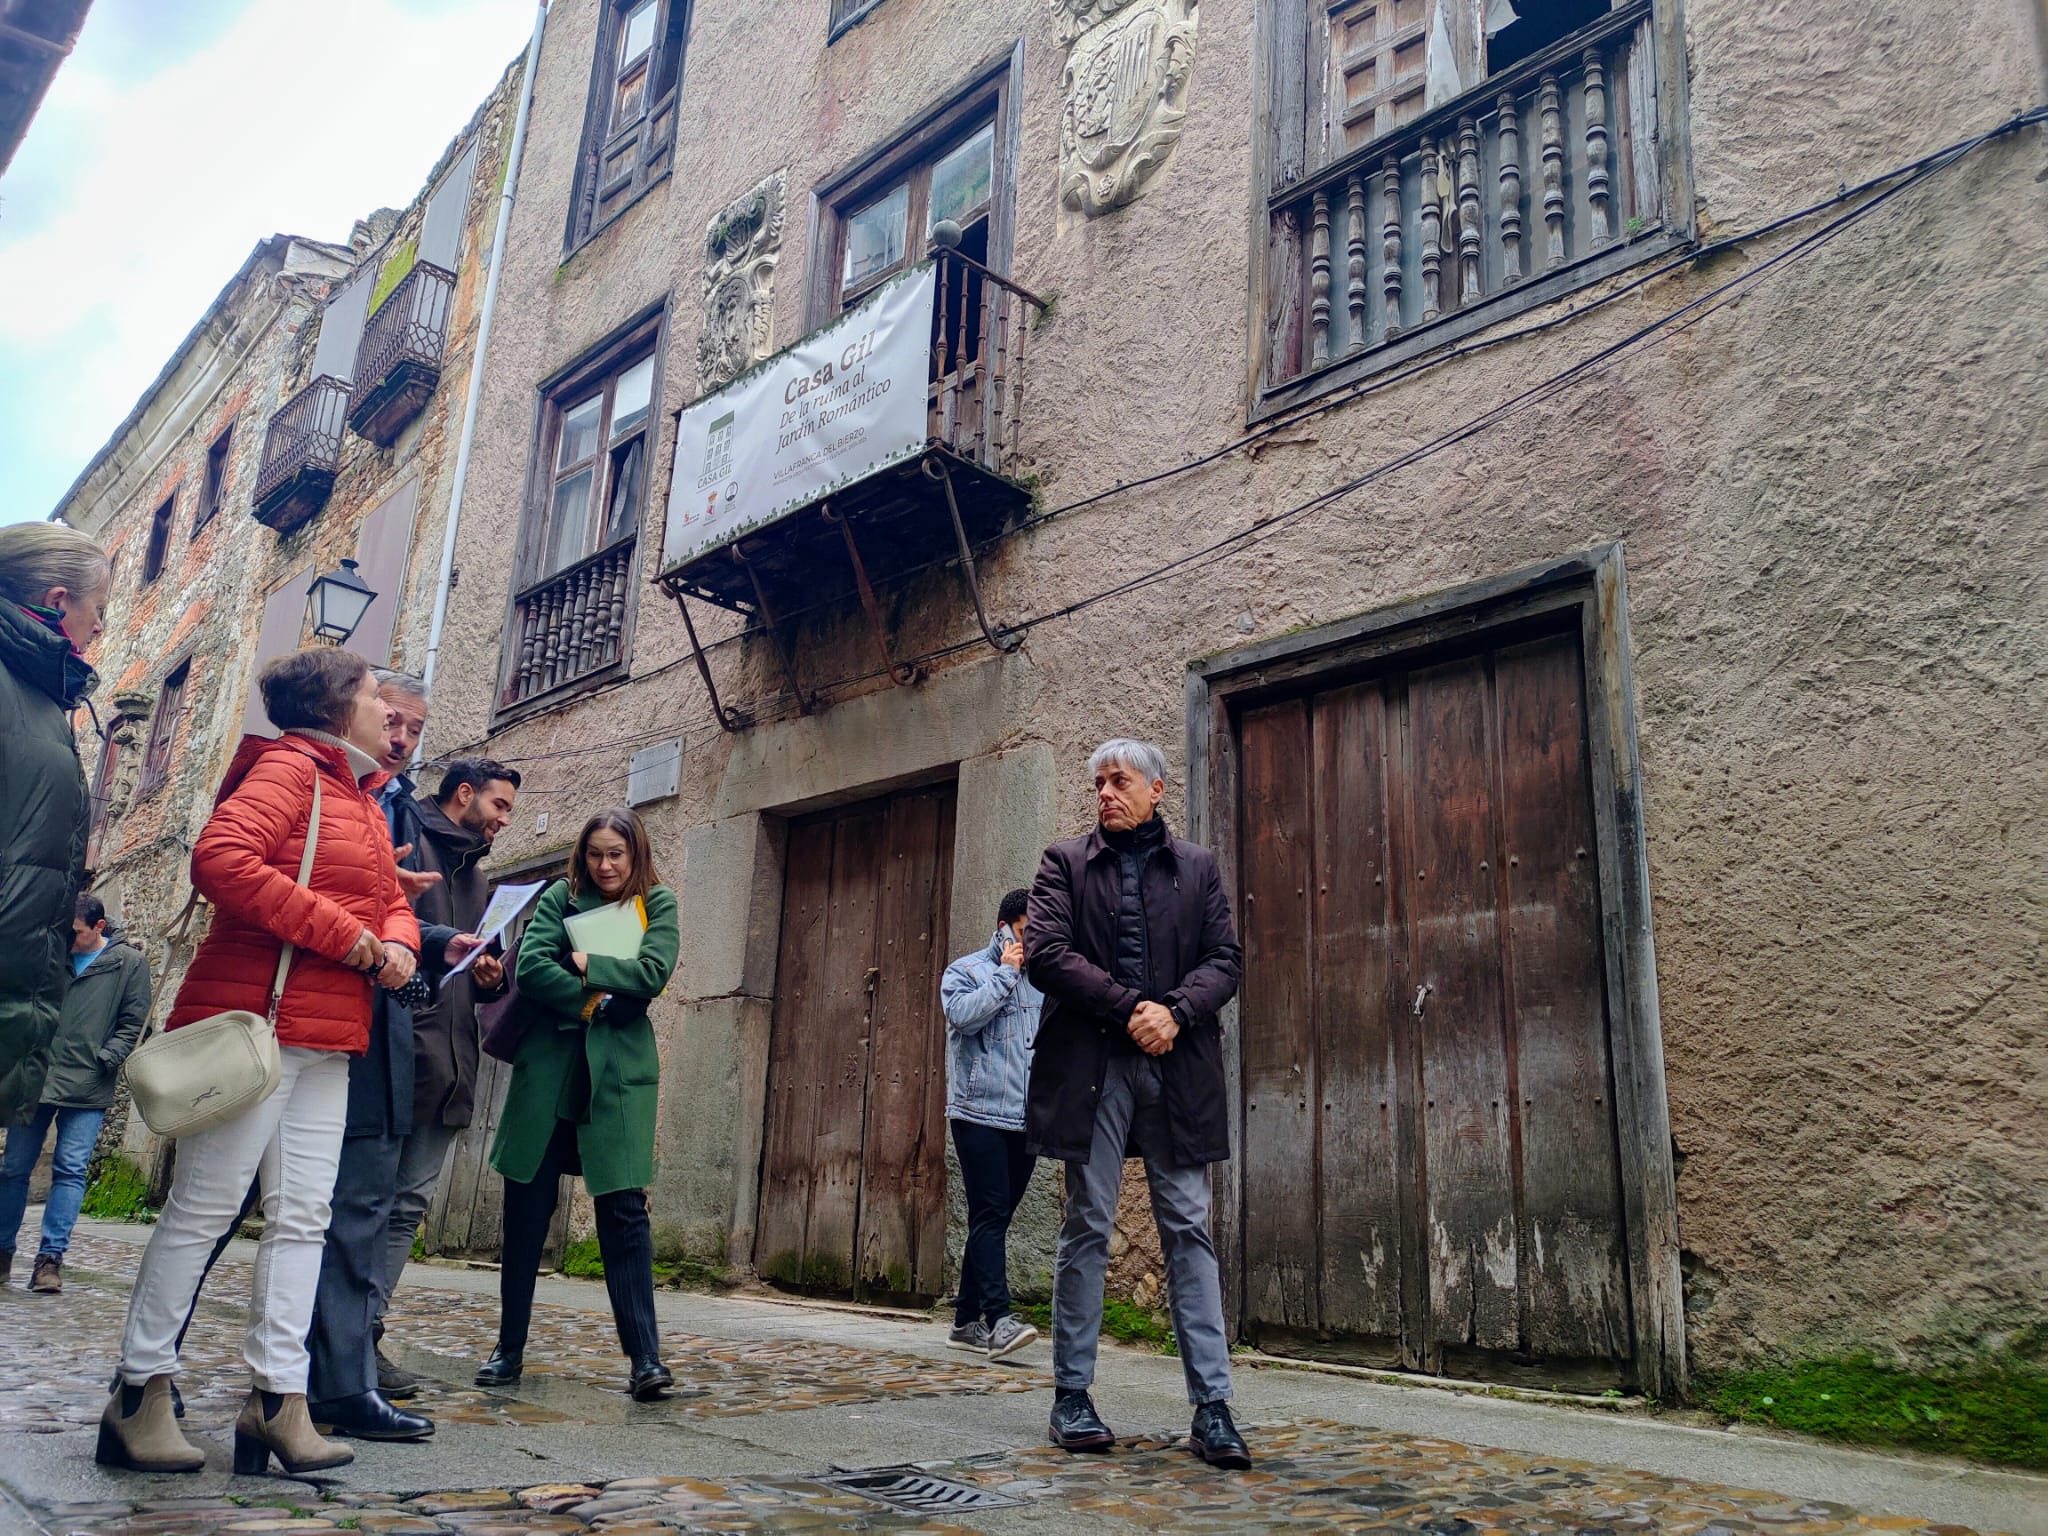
[{"xmin": 127, "ymin": 786, "xmax": 319, "ymax": 1137}]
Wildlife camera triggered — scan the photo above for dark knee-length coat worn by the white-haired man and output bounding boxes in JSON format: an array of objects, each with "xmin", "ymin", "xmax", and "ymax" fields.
[{"xmin": 1024, "ymin": 827, "xmax": 1243, "ymax": 1167}]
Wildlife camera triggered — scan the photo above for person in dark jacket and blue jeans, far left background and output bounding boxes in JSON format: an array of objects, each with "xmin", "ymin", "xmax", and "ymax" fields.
[{"xmin": 0, "ymin": 895, "xmax": 150, "ymax": 1294}]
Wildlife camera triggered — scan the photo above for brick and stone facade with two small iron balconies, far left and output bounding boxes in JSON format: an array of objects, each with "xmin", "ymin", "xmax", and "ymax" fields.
[{"xmin": 53, "ymin": 66, "xmax": 522, "ymax": 1180}]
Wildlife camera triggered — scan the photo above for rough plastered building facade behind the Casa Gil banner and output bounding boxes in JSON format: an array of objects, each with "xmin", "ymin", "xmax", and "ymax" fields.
[{"xmin": 430, "ymin": 0, "xmax": 2048, "ymax": 1393}]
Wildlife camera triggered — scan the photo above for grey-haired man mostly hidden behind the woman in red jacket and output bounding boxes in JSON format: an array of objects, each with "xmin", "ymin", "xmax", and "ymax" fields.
[{"xmin": 305, "ymin": 668, "xmax": 453, "ymax": 1440}]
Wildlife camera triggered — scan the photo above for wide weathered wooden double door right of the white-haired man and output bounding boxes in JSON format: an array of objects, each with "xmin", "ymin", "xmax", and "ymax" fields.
[{"xmin": 1239, "ymin": 627, "xmax": 1634, "ymax": 1384}]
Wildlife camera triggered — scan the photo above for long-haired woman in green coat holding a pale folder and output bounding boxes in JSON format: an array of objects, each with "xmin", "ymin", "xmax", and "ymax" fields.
[{"xmin": 477, "ymin": 809, "xmax": 680, "ymax": 1403}]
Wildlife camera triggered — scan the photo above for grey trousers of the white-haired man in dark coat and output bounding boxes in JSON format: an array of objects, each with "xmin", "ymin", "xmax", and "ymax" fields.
[{"xmin": 1053, "ymin": 1057, "xmax": 1231, "ymax": 1405}]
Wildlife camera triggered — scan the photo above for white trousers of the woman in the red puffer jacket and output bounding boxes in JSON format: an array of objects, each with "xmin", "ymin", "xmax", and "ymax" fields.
[{"xmin": 121, "ymin": 1047, "xmax": 348, "ymax": 1393}]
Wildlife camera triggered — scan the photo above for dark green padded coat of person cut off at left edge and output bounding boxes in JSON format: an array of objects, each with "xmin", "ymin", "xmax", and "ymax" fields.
[{"xmin": 0, "ymin": 600, "xmax": 98, "ymax": 1122}]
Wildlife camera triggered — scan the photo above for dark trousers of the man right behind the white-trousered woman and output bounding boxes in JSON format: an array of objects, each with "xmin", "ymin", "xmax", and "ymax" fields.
[{"xmin": 305, "ymin": 1137, "xmax": 406, "ymax": 1403}]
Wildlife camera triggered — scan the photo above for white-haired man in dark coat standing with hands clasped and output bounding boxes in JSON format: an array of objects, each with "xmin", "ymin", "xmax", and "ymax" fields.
[{"xmin": 1024, "ymin": 739, "xmax": 1251, "ymax": 1470}]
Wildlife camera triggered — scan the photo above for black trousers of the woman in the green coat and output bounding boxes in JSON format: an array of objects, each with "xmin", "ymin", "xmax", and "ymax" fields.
[{"xmin": 498, "ymin": 1120, "xmax": 662, "ymax": 1360}]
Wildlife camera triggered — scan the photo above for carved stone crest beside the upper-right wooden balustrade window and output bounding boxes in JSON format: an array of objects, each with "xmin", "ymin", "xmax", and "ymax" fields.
[{"xmin": 1053, "ymin": 0, "xmax": 1198, "ymax": 217}]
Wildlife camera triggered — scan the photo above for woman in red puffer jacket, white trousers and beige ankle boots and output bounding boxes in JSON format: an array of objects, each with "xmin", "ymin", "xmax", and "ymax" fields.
[{"xmin": 98, "ymin": 649, "xmax": 420, "ymax": 1473}]
